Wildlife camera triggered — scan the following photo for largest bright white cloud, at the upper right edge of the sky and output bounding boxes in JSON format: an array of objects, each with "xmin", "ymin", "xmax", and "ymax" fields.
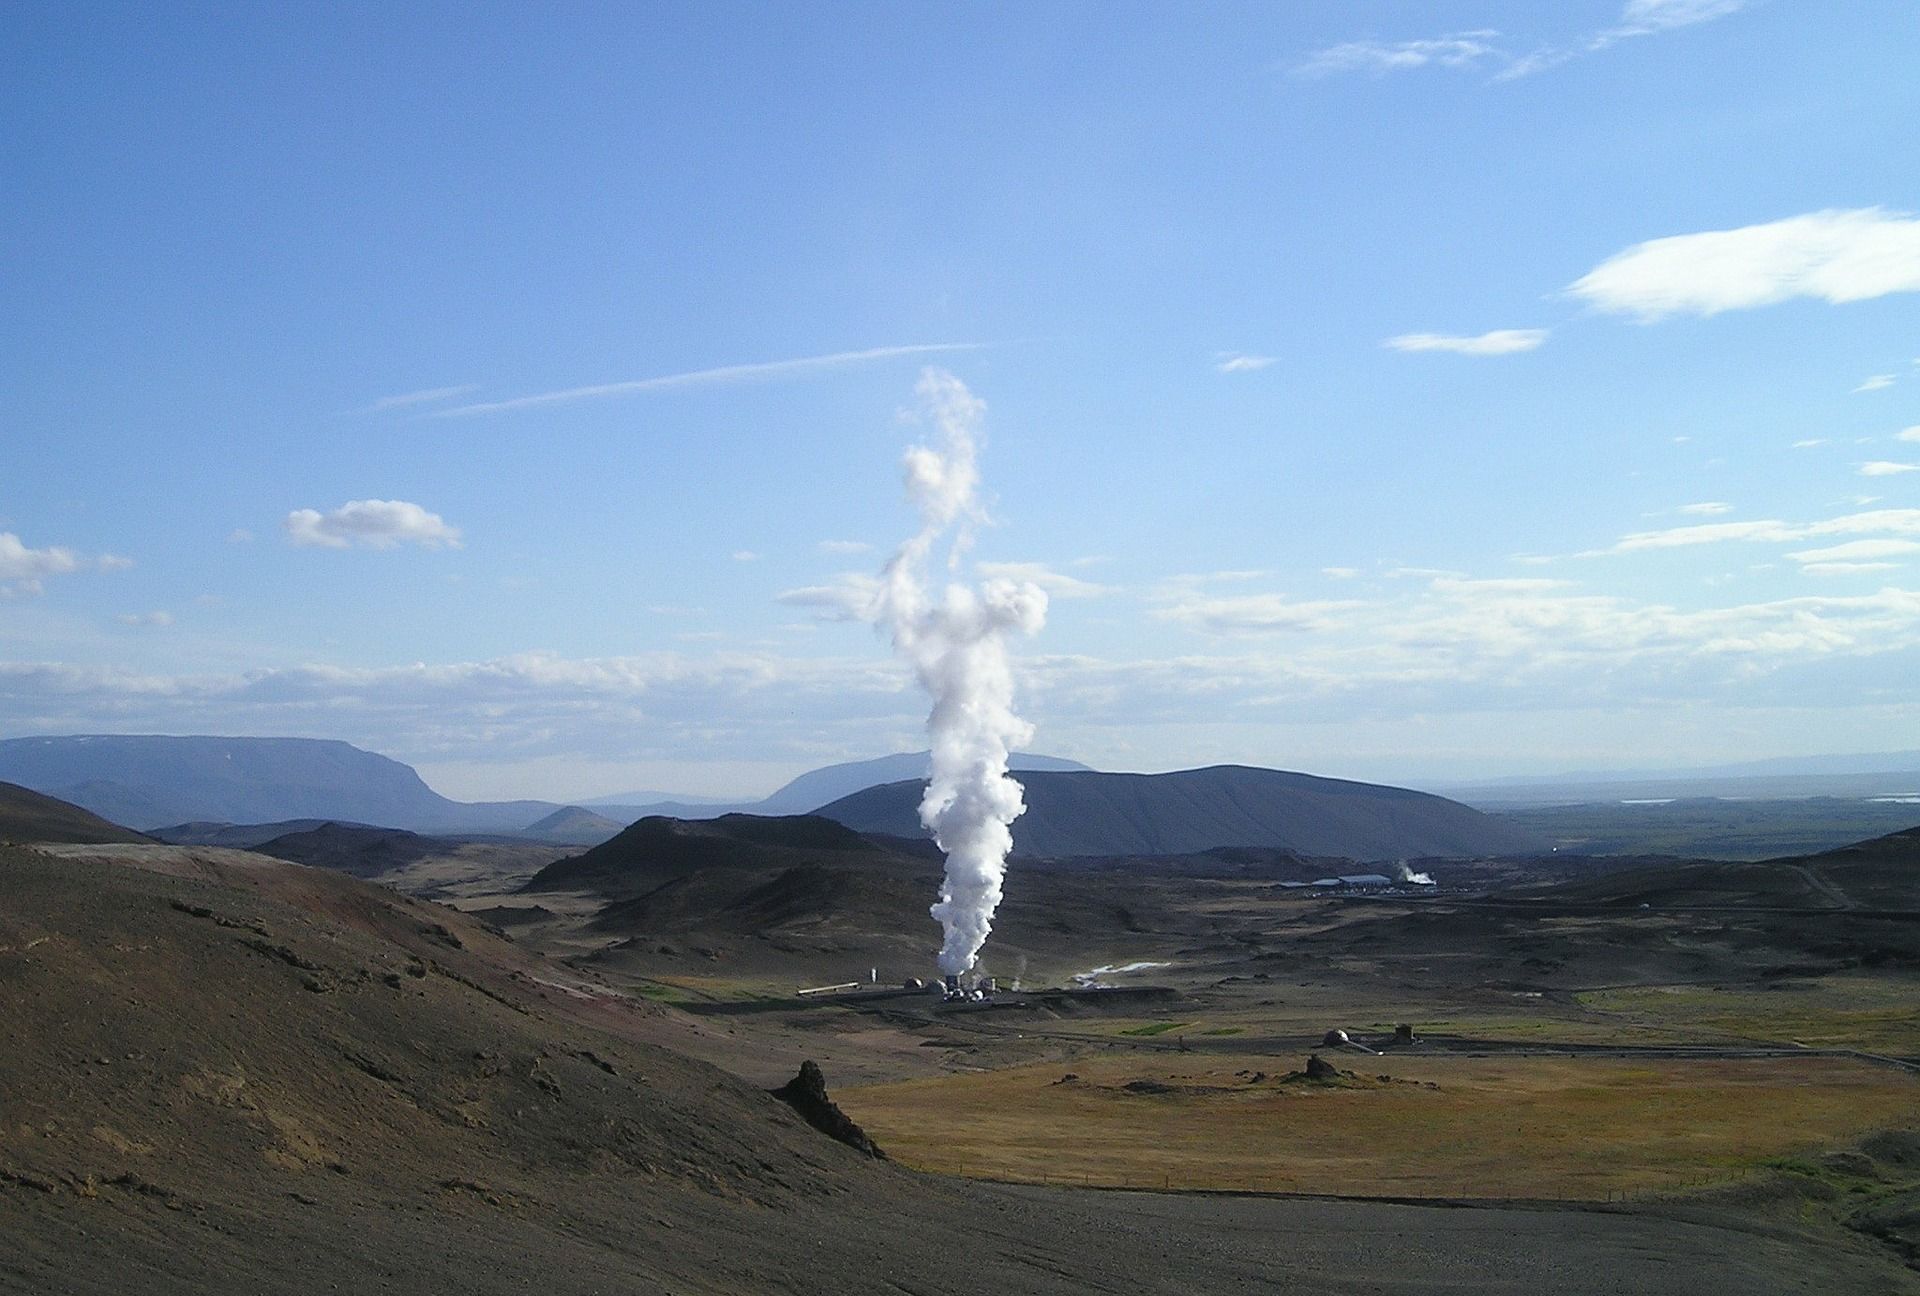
[{"xmin": 1569, "ymin": 207, "xmax": 1920, "ymax": 323}]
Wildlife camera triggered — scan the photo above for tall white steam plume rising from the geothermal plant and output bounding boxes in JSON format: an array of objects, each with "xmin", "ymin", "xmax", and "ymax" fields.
[{"xmin": 874, "ymin": 369, "xmax": 1046, "ymax": 975}]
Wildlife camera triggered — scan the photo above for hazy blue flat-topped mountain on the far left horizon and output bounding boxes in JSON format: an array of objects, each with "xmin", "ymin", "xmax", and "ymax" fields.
[{"xmin": 0, "ymin": 733, "xmax": 557, "ymax": 831}]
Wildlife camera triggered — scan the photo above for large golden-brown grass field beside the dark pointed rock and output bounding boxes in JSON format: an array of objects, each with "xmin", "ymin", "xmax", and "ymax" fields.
[{"xmin": 835, "ymin": 1054, "xmax": 1920, "ymax": 1200}]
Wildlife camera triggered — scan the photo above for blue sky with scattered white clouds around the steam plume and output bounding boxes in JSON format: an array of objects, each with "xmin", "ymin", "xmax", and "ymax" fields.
[{"xmin": 0, "ymin": 0, "xmax": 1920, "ymax": 799}]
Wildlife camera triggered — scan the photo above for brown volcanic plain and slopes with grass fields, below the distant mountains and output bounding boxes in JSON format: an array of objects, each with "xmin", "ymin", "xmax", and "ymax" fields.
[{"xmin": 0, "ymin": 806, "xmax": 1920, "ymax": 1292}]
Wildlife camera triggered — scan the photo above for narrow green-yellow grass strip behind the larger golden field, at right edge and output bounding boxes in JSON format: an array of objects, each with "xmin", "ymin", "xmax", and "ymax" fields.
[{"xmin": 1578, "ymin": 975, "xmax": 1920, "ymax": 1056}]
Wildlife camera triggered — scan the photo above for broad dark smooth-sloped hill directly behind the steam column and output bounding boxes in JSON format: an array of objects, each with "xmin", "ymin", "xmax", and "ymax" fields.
[{"xmin": 820, "ymin": 764, "xmax": 1540, "ymax": 860}]
